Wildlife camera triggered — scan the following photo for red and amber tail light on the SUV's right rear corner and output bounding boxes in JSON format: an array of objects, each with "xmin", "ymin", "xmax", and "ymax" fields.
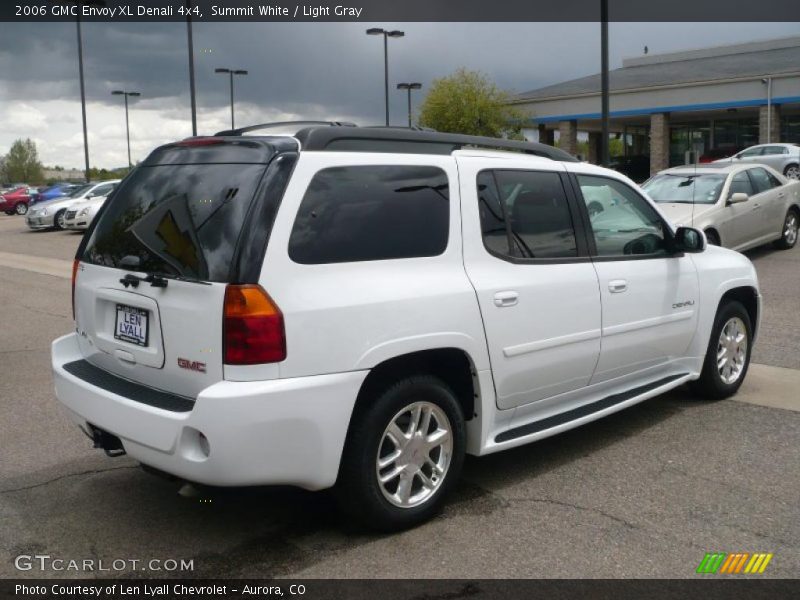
[{"xmin": 222, "ymin": 285, "xmax": 286, "ymax": 365}]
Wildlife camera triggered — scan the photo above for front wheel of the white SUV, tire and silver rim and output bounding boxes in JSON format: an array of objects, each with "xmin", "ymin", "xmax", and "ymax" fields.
[{"xmin": 693, "ymin": 300, "xmax": 753, "ymax": 400}]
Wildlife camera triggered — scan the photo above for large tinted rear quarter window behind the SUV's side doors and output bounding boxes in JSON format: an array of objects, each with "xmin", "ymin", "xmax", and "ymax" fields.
[{"xmin": 289, "ymin": 165, "xmax": 450, "ymax": 265}]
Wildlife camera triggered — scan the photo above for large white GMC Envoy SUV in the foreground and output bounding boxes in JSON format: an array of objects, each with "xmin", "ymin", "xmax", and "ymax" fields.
[{"xmin": 52, "ymin": 125, "xmax": 761, "ymax": 529}]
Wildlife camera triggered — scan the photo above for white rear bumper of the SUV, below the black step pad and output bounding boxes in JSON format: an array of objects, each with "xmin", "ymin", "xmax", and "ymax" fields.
[{"xmin": 52, "ymin": 333, "xmax": 367, "ymax": 490}]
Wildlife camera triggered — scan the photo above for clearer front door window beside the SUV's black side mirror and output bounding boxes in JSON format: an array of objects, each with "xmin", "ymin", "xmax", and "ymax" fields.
[{"xmin": 578, "ymin": 175, "xmax": 667, "ymax": 256}]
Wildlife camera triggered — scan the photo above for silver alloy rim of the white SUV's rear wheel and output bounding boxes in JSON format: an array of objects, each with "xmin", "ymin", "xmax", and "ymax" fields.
[{"xmin": 375, "ymin": 402, "xmax": 453, "ymax": 508}]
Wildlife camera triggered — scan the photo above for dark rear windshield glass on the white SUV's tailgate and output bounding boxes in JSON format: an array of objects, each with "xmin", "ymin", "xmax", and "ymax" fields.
[{"xmin": 82, "ymin": 164, "xmax": 266, "ymax": 283}]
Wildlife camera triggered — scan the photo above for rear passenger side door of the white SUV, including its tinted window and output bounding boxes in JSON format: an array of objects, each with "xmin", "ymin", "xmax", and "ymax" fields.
[{"xmin": 458, "ymin": 157, "xmax": 600, "ymax": 409}]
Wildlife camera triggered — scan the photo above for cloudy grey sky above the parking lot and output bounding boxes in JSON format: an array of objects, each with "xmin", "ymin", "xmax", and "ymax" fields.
[{"xmin": 0, "ymin": 23, "xmax": 798, "ymax": 168}]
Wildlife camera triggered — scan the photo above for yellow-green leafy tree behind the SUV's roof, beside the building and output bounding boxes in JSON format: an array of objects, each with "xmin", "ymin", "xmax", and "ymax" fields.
[{"xmin": 419, "ymin": 68, "xmax": 528, "ymax": 138}]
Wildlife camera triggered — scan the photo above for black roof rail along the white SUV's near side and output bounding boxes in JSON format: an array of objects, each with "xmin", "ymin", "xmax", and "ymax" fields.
[{"xmin": 294, "ymin": 127, "xmax": 578, "ymax": 162}]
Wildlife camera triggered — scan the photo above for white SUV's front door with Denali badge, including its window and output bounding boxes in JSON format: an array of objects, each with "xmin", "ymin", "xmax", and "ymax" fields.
[{"xmin": 577, "ymin": 167, "xmax": 700, "ymax": 384}]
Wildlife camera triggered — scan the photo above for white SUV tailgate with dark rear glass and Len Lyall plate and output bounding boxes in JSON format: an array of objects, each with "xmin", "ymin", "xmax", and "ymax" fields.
[{"xmin": 75, "ymin": 146, "xmax": 284, "ymax": 398}]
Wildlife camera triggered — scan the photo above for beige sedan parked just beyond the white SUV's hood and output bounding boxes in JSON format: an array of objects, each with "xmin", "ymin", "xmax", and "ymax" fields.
[{"xmin": 642, "ymin": 163, "xmax": 800, "ymax": 251}]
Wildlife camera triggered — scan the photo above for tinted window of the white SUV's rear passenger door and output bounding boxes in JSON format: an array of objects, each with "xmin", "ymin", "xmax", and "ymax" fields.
[{"xmin": 477, "ymin": 171, "xmax": 578, "ymax": 258}]
